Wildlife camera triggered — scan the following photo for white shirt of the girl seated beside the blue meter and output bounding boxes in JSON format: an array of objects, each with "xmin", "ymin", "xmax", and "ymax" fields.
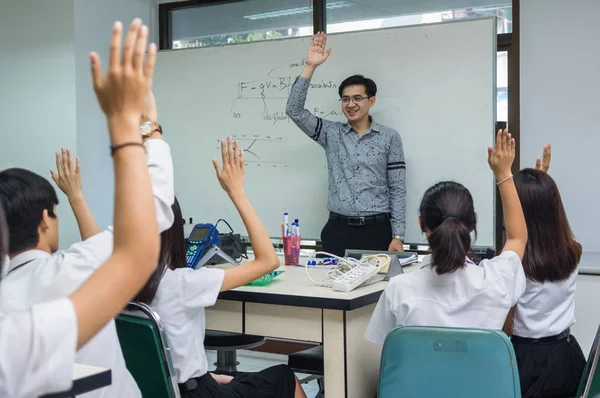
[{"xmin": 151, "ymin": 268, "xmax": 224, "ymax": 383}]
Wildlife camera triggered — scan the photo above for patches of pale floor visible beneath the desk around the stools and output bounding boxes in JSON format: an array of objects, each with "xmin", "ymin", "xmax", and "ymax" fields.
[{"xmin": 206, "ymin": 350, "xmax": 319, "ymax": 398}]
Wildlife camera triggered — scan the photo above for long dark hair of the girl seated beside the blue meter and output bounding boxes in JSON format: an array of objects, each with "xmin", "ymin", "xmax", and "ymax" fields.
[{"xmin": 134, "ymin": 198, "xmax": 187, "ymax": 305}]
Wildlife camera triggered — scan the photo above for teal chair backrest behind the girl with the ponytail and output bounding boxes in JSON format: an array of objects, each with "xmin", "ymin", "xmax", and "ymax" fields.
[{"xmin": 378, "ymin": 326, "xmax": 521, "ymax": 398}]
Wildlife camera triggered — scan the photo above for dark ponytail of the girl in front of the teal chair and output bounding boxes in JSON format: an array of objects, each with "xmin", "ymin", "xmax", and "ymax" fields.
[{"xmin": 428, "ymin": 217, "xmax": 471, "ymax": 275}]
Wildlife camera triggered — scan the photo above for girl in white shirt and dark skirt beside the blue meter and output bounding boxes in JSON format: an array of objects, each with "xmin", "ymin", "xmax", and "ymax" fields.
[{"xmin": 137, "ymin": 137, "xmax": 305, "ymax": 398}]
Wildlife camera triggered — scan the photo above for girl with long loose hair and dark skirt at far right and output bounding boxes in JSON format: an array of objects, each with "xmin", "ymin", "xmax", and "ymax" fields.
[{"xmin": 508, "ymin": 145, "xmax": 585, "ymax": 398}]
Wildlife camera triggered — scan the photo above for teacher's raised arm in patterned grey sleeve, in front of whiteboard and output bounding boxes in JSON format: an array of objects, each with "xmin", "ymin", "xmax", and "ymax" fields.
[{"xmin": 286, "ymin": 32, "xmax": 333, "ymax": 147}]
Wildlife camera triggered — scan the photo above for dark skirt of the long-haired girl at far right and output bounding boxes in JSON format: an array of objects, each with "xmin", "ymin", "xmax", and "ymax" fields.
[{"xmin": 512, "ymin": 334, "xmax": 585, "ymax": 398}]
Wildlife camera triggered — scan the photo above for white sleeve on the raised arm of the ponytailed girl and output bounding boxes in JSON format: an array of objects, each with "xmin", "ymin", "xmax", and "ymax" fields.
[{"xmin": 482, "ymin": 250, "xmax": 527, "ymax": 307}]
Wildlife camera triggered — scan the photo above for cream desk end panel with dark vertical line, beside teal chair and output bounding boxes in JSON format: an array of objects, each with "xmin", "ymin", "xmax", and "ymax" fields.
[{"xmin": 323, "ymin": 304, "xmax": 381, "ymax": 398}]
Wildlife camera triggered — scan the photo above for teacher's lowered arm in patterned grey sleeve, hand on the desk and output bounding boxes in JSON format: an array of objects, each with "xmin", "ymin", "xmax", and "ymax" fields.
[{"xmin": 387, "ymin": 133, "xmax": 406, "ymax": 252}]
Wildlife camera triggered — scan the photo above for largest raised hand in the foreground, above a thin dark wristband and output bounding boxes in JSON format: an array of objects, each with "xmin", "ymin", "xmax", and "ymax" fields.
[{"xmin": 90, "ymin": 18, "xmax": 156, "ymax": 144}]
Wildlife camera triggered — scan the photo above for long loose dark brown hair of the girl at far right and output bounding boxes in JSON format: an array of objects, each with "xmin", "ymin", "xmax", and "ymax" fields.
[{"xmin": 514, "ymin": 169, "xmax": 582, "ymax": 283}]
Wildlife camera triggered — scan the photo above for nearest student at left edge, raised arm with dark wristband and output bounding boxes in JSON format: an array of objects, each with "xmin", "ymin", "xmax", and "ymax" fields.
[{"xmin": 0, "ymin": 19, "xmax": 159, "ymax": 397}]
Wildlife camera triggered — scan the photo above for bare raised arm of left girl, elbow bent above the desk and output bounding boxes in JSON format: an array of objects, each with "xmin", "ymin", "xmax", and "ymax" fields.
[{"xmin": 213, "ymin": 137, "xmax": 279, "ymax": 292}]
